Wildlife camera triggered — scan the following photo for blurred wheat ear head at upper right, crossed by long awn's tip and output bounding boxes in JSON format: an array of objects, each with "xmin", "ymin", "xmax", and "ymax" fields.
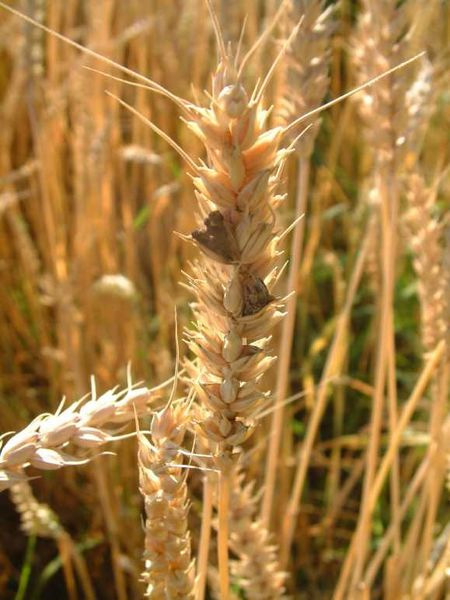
[{"xmin": 353, "ymin": 0, "xmax": 433, "ymax": 169}]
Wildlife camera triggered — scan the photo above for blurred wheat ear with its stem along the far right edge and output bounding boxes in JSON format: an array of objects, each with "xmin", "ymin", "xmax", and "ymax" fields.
[{"xmin": 405, "ymin": 172, "xmax": 450, "ymax": 593}]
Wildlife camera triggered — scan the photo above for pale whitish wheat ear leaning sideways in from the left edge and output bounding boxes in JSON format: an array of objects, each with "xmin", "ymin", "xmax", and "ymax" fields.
[{"xmin": 0, "ymin": 387, "xmax": 157, "ymax": 491}]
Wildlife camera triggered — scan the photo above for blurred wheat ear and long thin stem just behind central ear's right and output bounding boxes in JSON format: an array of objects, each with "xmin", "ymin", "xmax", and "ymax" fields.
[{"xmin": 261, "ymin": 0, "xmax": 333, "ymax": 525}]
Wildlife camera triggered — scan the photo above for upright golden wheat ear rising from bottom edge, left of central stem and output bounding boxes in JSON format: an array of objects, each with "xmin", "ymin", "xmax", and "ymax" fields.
[{"xmin": 138, "ymin": 404, "xmax": 194, "ymax": 600}]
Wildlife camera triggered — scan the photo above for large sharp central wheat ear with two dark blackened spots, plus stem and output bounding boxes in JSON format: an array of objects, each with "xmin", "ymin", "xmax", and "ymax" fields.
[{"xmin": 179, "ymin": 8, "xmax": 306, "ymax": 599}]
